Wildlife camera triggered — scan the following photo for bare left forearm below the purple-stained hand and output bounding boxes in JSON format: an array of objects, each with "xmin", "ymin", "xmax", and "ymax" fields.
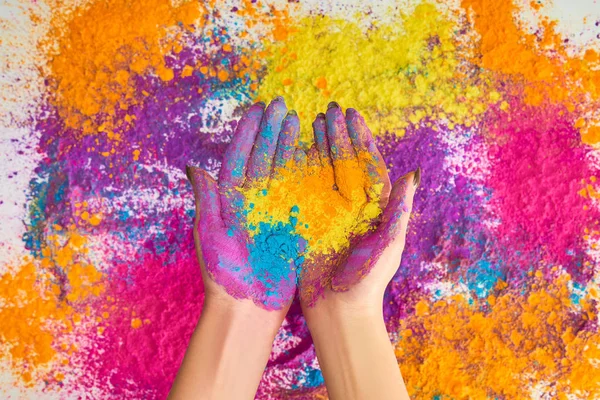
[{"xmin": 169, "ymin": 300, "xmax": 281, "ymax": 400}]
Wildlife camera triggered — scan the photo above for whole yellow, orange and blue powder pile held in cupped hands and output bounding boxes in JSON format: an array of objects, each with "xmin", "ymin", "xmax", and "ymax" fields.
[{"xmin": 242, "ymin": 139, "xmax": 383, "ymax": 302}]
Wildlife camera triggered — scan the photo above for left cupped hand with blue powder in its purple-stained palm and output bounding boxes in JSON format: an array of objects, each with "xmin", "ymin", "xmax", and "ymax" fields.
[{"xmin": 187, "ymin": 98, "xmax": 303, "ymax": 310}]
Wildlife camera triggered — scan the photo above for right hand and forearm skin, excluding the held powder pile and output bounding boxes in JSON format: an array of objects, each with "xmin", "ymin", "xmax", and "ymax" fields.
[{"xmin": 300, "ymin": 103, "xmax": 420, "ymax": 399}]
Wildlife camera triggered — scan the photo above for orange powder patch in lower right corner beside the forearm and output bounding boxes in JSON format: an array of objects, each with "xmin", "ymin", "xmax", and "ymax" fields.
[{"xmin": 396, "ymin": 275, "xmax": 600, "ymax": 399}]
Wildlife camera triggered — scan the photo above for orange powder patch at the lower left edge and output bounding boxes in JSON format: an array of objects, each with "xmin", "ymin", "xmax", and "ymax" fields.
[{"xmin": 0, "ymin": 229, "xmax": 103, "ymax": 385}]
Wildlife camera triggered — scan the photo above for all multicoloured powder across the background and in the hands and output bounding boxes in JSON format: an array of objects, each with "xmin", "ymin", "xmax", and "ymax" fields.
[{"xmin": 0, "ymin": 0, "xmax": 600, "ymax": 399}]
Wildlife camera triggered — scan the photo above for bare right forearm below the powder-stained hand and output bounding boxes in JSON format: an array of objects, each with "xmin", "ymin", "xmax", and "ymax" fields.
[{"xmin": 305, "ymin": 306, "xmax": 409, "ymax": 400}]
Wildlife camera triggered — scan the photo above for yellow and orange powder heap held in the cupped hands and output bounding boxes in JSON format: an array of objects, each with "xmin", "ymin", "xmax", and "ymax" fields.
[{"xmin": 243, "ymin": 159, "xmax": 383, "ymax": 258}]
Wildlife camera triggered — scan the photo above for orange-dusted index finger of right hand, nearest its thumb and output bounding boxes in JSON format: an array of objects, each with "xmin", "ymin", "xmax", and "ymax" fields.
[{"xmin": 346, "ymin": 108, "xmax": 392, "ymax": 209}]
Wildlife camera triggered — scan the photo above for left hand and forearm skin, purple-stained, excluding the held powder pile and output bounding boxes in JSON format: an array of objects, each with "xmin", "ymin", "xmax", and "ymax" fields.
[{"xmin": 168, "ymin": 98, "xmax": 299, "ymax": 400}]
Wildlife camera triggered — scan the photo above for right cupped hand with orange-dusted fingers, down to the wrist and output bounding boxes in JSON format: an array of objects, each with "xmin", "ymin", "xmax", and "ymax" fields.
[{"xmin": 299, "ymin": 103, "xmax": 420, "ymax": 312}]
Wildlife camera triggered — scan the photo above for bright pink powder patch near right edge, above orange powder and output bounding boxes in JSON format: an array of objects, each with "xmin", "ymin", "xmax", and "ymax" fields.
[{"xmin": 486, "ymin": 94, "xmax": 600, "ymax": 281}]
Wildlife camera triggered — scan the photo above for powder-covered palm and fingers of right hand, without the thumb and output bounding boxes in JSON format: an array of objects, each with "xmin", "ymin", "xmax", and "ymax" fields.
[{"xmin": 300, "ymin": 107, "xmax": 398, "ymax": 305}]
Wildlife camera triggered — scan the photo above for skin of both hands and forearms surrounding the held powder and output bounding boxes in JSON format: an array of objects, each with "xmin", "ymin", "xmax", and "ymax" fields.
[{"xmin": 169, "ymin": 98, "xmax": 420, "ymax": 399}]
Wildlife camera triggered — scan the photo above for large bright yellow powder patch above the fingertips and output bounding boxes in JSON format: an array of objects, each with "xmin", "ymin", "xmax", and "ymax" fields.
[{"xmin": 258, "ymin": 3, "xmax": 500, "ymax": 140}]
